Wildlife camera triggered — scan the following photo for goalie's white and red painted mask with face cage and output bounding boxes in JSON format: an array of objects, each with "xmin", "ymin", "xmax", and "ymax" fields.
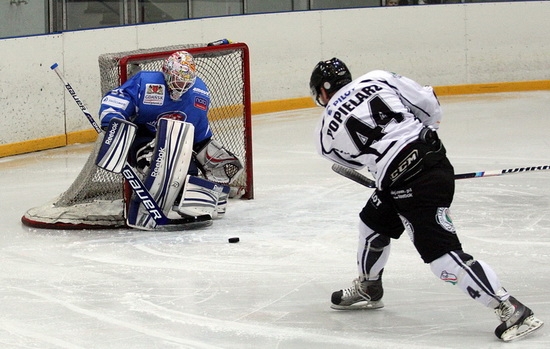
[{"xmin": 162, "ymin": 51, "xmax": 197, "ymax": 101}]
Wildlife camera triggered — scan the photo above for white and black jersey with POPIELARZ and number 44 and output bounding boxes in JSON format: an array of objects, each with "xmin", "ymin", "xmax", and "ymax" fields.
[{"xmin": 315, "ymin": 70, "xmax": 441, "ymax": 188}]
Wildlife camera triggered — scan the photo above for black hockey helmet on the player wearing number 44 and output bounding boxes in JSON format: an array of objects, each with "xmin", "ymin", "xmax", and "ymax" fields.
[{"xmin": 309, "ymin": 57, "xmax": 351, "ymax": 107}]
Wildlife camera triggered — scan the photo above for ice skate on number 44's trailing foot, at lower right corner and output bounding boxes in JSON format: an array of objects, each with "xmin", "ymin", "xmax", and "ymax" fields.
[{"xmin": 495, "ymin": 296, "xmax": 544, "ymax": 342}]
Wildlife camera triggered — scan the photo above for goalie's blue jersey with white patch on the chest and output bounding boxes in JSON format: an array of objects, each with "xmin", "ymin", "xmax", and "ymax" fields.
[{"xmin": 99, "ymin": 71, "xmax": 212, "ymax": 143}]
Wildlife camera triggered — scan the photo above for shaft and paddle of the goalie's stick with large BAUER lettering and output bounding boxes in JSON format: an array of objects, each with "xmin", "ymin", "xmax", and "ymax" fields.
[{"xmin": 50, "ymin": 63, "xmax": 168, "ymax": 225}]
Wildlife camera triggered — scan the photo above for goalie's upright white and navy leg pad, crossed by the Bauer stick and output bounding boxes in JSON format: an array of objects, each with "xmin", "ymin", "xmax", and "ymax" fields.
[{"xmin": 126, "ymin": 118, "xmax": 194, "ymax": 229}]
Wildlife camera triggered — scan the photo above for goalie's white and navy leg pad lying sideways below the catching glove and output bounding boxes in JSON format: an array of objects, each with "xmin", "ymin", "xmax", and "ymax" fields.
[{"xmin": 175, "ymin": 176, "xmax": 229, "ymax": 218}]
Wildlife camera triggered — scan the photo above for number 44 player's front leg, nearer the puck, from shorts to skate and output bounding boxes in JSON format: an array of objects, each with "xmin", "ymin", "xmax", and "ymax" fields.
[{"xmin": 331, "ymin": 191, "xmax": 403, "ymax": 310}]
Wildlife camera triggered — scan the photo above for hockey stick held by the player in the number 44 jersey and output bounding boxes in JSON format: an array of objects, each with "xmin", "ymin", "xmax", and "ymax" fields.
[{"xmin": 332, "ymin": 164, "xmax": 550, "ymax": 188}]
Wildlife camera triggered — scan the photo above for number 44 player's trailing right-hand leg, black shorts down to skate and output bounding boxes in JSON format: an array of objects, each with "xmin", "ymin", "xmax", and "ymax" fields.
[{"xmin": 394, "ymin": 157, "xmax": 542, "ymax": 341}]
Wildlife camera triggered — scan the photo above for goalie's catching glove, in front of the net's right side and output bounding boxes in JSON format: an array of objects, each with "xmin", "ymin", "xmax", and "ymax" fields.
[{"xmin": 196, "ymin": 140, "xmax": 244, "ymax": 184}]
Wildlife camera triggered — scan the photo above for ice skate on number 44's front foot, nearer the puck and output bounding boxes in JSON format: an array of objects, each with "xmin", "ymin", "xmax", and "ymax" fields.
[{"xmin": 330, "ymin": 279, "xmax": 384, "ymax": 310}]
